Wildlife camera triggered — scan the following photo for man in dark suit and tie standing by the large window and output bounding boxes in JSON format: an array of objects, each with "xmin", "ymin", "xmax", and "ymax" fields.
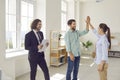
[{"xmin": 25, "ymin": 19, "xmax": 50, "ymax": 80}]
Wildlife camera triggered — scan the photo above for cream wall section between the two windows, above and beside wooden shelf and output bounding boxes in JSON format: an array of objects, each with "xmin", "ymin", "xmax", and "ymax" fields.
[{"xmin": 46, "ymin": 0, "xmax": 61, "ymax": 65}]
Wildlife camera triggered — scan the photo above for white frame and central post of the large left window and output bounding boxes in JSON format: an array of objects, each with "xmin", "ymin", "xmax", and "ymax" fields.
[{"xmin": 5, "ymin": 0, "xmax": 36, "ymax": 53}]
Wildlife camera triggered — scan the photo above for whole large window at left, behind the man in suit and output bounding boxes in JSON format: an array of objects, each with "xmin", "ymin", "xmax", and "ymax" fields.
[{"xmin": 6, "ymin": 0, "xmax": 34, "ymax": 52}]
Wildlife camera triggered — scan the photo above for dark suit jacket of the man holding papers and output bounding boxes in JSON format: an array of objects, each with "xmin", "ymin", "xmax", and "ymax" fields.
[{"xmin": 25, "ymin": 31, "xmax": 44, "ymax": 60}]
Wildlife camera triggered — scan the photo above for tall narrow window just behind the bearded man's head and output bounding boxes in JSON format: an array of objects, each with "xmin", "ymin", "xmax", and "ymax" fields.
[{"xmin": 61, "ymin": 0, "xmax": 67, "ymax": 31}]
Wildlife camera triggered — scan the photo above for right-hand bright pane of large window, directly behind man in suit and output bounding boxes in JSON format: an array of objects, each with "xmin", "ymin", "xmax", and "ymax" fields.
[{"xmin": 20, "ymin": 1, "xmax": 34, "ymax": 48}]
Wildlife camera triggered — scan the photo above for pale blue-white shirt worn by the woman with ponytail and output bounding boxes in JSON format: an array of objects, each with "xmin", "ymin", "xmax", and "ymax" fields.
[{"xmin": 93, "ymin": 29, "xmax": 109, "ymax": 64}]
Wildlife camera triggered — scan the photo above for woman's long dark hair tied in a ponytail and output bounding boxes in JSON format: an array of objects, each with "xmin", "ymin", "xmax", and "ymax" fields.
[{"xmin": 99, "ymin": 23, "xmax": 111, "ymax": 49}]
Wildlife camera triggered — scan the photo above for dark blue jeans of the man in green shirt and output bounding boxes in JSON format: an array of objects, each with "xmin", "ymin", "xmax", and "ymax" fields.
[{"xmin": 66, "ymin": 56, "xmax": 80, "ymax": 80}]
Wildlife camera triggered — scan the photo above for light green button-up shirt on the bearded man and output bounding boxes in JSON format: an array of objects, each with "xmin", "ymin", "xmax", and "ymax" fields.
[{"xmin": 65, "ymin": 29, "xmax": 88, "ymax": 57}]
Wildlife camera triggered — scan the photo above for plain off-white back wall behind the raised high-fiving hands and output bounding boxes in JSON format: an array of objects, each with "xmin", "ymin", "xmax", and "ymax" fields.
[{"xmin": 80, "ymin": 0, "xmax": 120, "ymax": 41}]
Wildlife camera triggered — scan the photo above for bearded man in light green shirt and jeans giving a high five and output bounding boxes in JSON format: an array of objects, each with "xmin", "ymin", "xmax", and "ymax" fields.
[{"xmin": 65, "ymin": 19, "xmax": 89, "ymax": 80}]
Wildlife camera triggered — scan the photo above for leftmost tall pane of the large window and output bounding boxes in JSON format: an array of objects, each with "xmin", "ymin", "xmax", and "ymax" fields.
[{"xmin": 6, "ymin": 0, "xmax": 17, "ymax": 50}]
